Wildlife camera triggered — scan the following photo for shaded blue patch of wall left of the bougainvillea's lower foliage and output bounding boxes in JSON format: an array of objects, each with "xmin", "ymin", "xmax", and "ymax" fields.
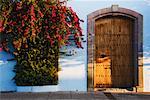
[{"xmin": 0, "ymin": 51, "xmax": 16, "ymax": 92}]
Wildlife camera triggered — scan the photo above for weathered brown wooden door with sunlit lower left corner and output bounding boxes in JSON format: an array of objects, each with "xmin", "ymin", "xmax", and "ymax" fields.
[{"xmin": 94, "ymin": 16, "xmax": 134, "ymax": 88}]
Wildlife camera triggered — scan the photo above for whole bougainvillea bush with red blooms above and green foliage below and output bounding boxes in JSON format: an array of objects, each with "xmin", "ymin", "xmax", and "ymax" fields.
[{"xmin": 0, "ymin": 0, "xmax": 83, "ymax": 85}]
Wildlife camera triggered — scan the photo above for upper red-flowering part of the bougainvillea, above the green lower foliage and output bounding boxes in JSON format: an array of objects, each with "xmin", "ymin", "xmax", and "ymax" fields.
[{"xmin": 0, "ymin": 0, "xmax": 82, "ymax": 54}]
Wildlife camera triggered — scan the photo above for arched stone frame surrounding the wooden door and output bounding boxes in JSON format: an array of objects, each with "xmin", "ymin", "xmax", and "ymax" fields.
[{"xmin": 87, "ymin": 5, "xmax": 143, "ymax": 91}]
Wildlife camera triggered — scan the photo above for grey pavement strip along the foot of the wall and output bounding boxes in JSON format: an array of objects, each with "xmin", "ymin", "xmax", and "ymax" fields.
[{"xmin": 0, "ymin": 92, "xmax": 150, "ymax": 100}]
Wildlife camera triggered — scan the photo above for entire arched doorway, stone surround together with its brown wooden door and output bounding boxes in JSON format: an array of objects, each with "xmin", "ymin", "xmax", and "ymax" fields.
[{"xmin": 88, "ymin": 5, "xmax": 143, "ymax": 91}]
